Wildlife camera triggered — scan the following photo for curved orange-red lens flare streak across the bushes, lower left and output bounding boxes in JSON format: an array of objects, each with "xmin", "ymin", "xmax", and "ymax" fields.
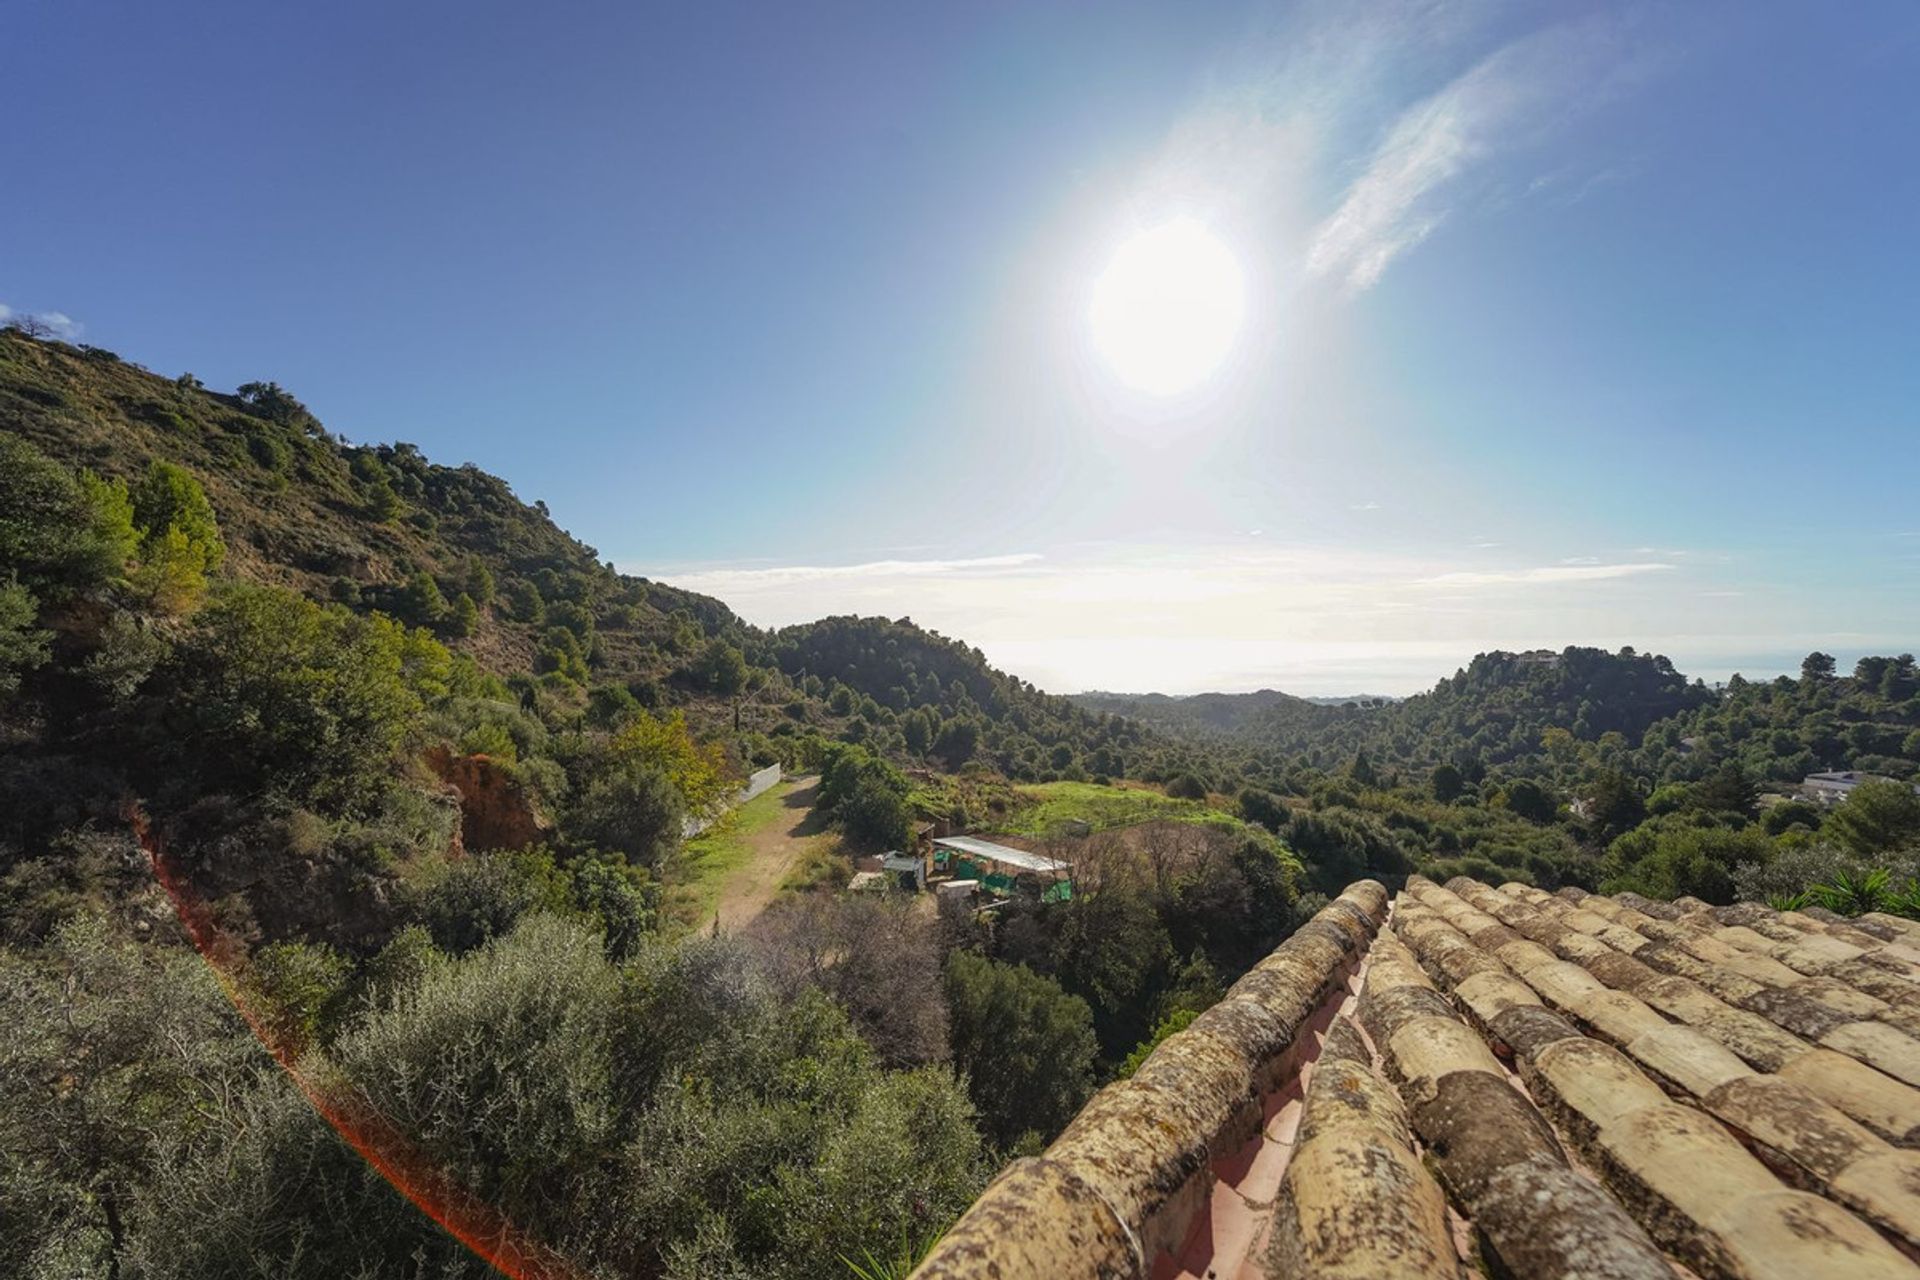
[{"xmin": 127, "ymin": 808, "xmax": 580, "ymax": 1280}]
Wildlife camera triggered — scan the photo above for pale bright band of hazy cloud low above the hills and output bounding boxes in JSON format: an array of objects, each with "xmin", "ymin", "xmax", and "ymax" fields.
[{"xmin": 648, "ymin": 539, "xmax": 1916, "ymax": 697}]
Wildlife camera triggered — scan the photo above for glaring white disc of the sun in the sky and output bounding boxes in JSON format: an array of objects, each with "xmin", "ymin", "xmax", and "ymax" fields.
[{"xmin": 1089, "ymin": 219, "xmax": 1246, "ymax": 395}]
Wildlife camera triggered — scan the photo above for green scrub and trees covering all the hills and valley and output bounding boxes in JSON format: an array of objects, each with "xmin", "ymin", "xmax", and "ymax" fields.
[{"xmin": 0, "ymin": 332, "xmax": 1920, "ymax": 1276}]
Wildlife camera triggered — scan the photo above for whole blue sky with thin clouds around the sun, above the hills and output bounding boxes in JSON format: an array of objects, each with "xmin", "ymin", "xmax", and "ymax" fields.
[{"xmin": 0, "ymin": 0, "xmax": 1920, "ymax": 693}]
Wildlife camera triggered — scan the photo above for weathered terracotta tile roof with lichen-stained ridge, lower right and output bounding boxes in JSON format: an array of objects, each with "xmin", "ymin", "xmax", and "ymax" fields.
[{"xmin": 916, "ymin": 875, "xmax": 1920, "ymax": 1280}]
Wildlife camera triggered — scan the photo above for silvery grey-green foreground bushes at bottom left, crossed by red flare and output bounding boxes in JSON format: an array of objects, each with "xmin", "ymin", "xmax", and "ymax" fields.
[{"xmin": 0, "ymin": 912, "xmax": 987, "ymax": 1280}]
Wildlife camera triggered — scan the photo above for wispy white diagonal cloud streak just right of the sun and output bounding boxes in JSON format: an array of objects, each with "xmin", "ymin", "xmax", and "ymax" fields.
[{"xmin": 1308, "ymin": 19, "xmax": 1620, "ymax": 290}]
